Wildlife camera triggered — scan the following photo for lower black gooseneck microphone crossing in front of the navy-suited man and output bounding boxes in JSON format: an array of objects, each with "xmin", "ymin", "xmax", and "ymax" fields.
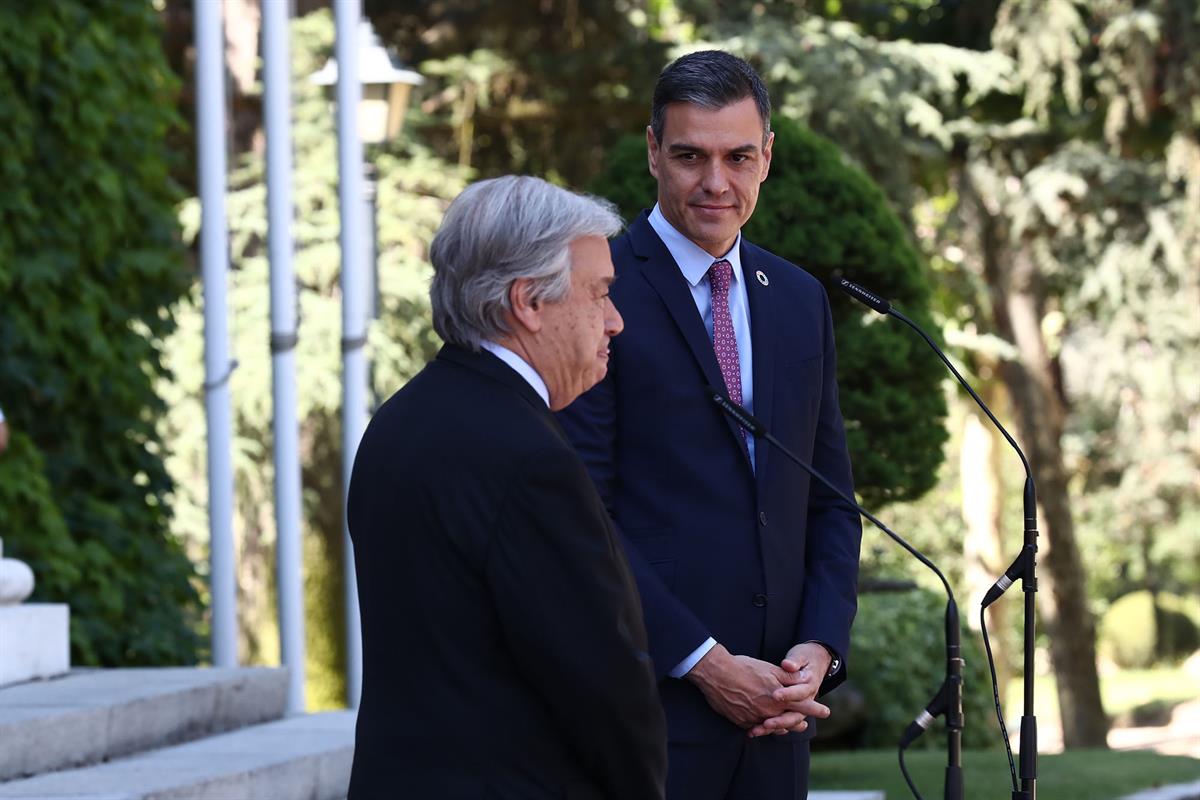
[{"xmin": 704, "ymin": 386, "xmax": 964, "ymax": 786}]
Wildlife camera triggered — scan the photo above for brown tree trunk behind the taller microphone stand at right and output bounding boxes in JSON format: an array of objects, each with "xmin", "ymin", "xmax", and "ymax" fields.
[{"xmin": 983, "ymin": 217, "xmax": 1109, "ymax": 747}]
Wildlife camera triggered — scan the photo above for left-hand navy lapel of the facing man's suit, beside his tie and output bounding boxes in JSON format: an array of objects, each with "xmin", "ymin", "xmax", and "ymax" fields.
[{"xmin": 629, "ymin": 211, "xmax": 757, "ymax": 469}]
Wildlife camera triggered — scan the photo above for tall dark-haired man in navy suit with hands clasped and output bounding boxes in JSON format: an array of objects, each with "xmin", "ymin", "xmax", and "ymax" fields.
[{"xmin": 560, "ymin": 50, "xmax": 862, "ymax": 800}]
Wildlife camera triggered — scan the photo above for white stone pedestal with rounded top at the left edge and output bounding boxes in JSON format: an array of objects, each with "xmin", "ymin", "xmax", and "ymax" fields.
[{"xmin": 0, "ymin": 540, "xmax": 71, "ymax": 686}]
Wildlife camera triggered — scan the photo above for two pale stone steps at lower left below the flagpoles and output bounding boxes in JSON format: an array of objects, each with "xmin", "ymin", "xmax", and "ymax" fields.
[{"xmin": 0, "ymin": 668, "xmax": 354, "ymax": 800}]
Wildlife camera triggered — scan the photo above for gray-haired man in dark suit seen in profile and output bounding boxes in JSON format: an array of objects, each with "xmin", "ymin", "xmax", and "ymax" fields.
[{"xmin": 348, "ymin": 176, "xmax": 666, "ymax": 800}]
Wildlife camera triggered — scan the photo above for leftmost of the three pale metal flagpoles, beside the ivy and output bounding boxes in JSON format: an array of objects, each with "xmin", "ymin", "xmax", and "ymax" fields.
[{"xmin": 193, "ymin": 0, "xmax": 238, "ymax": 667}]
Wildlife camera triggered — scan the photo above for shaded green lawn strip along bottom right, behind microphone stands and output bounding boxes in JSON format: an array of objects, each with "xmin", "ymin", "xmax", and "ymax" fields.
[{"xmin": 809, "ymin": 750, "xmax": 1200, "ymax": 800}]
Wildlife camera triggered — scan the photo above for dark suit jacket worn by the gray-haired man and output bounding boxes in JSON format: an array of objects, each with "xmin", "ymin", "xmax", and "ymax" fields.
[{"xmin": 348, "ymin": 345, "xmax": 666, "ymax": 800}]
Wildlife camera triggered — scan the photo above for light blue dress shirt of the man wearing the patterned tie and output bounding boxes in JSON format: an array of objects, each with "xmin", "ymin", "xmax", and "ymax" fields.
[{"xmin": 648, "ymin": 203, "xmax": 755, "ymax": 678}]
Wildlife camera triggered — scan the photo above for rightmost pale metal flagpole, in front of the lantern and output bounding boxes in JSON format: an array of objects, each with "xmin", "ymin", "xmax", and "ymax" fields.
[{"xmin": 334, "ymin": 0, "xmax": 367, "ymax": 709}]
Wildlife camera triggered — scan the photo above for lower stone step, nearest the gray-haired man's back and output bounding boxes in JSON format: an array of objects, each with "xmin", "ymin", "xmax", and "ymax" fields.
[{"xmin": 0, "ymin": 711, "xmax": 355, "ymax": 800}]
